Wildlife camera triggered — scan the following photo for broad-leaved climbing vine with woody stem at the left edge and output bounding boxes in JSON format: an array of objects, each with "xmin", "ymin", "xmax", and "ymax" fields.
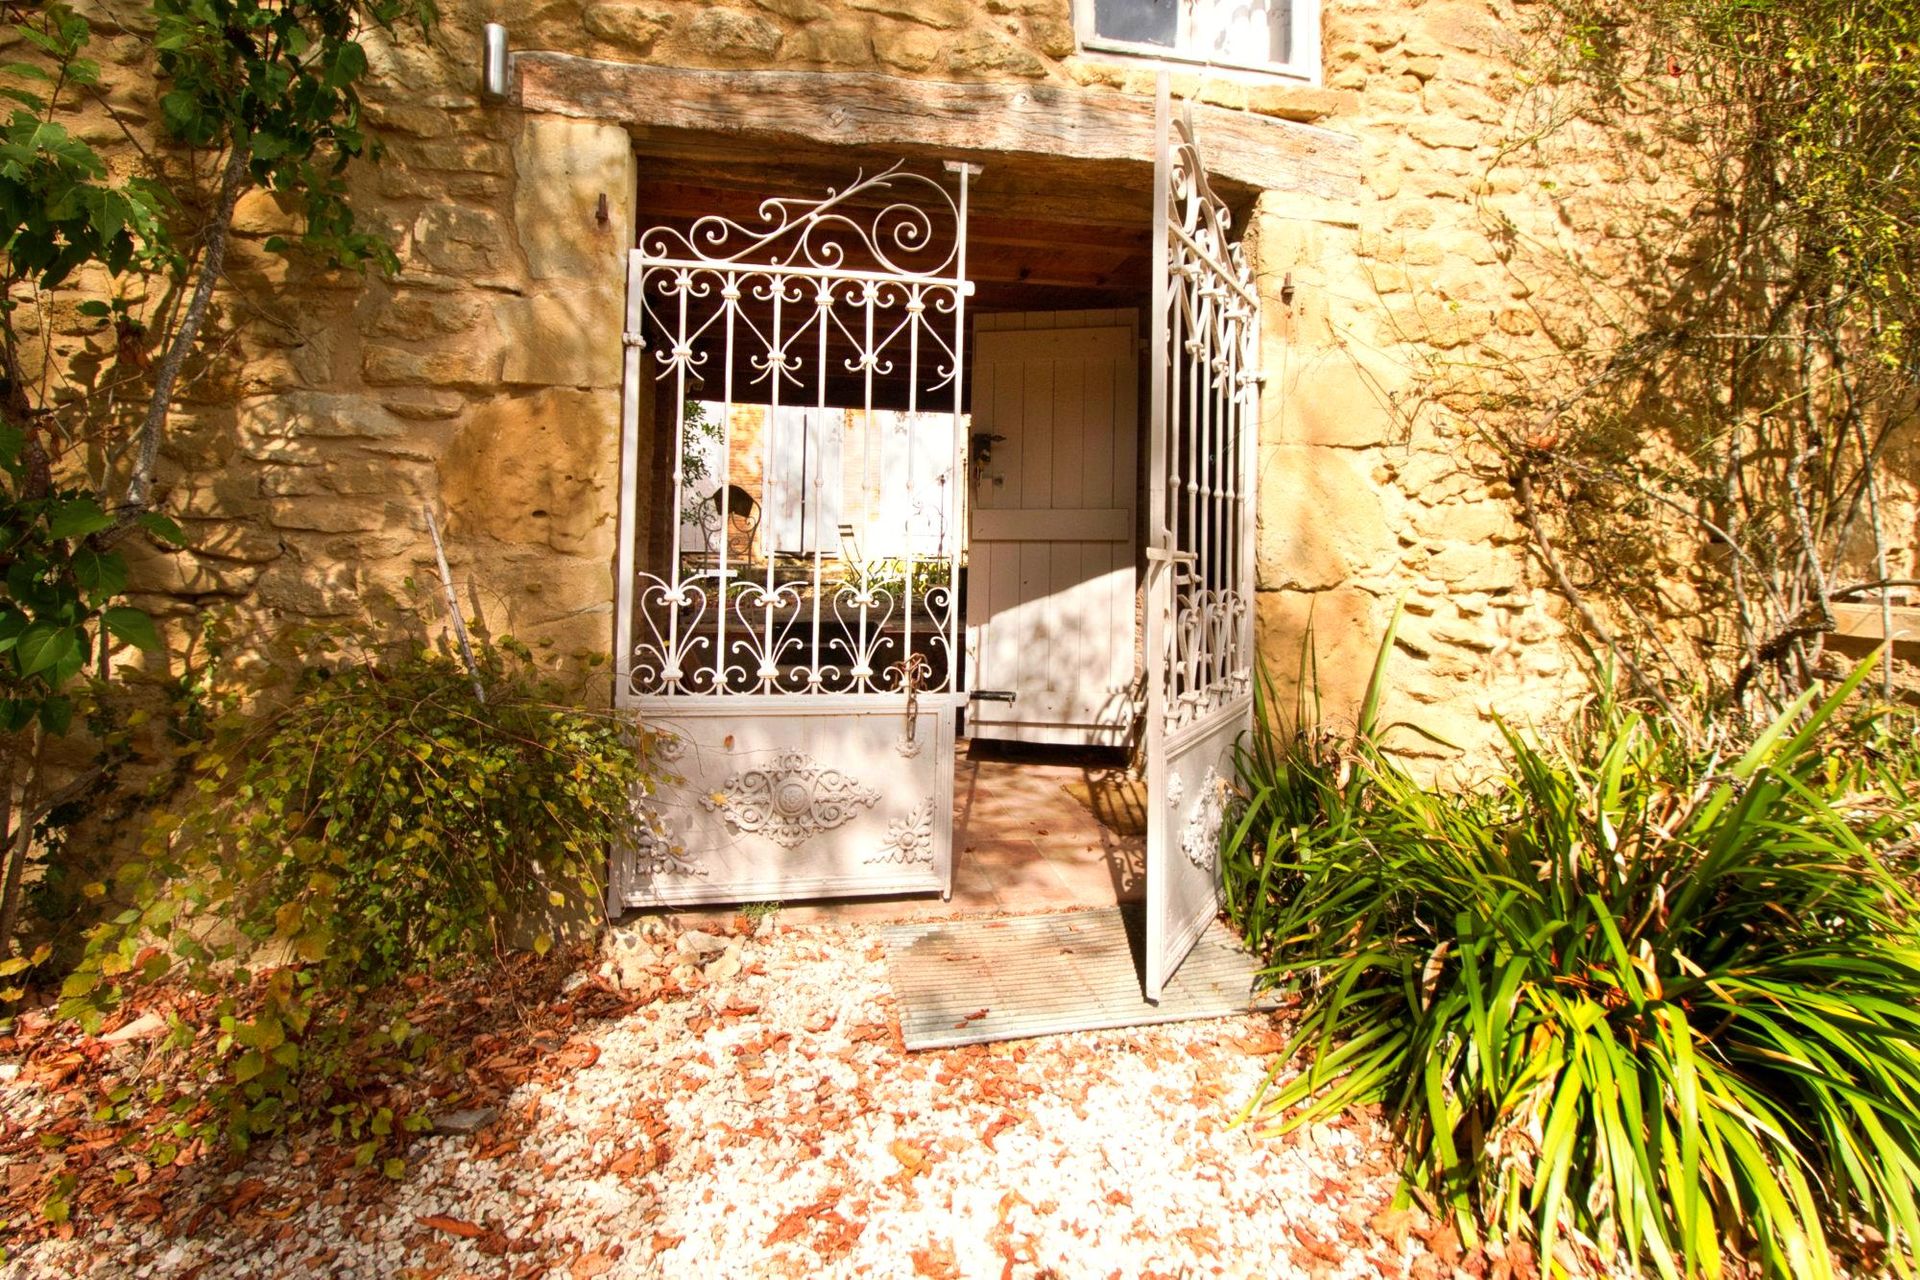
[{"xmin": 0, "ymin": 0, "xmax": 434, "ymax": 971}]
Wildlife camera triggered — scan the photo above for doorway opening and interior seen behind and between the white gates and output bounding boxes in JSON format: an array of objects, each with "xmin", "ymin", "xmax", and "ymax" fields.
[{"xmin": 614, "ymin": 136, "xmax": 1152, "ymax": 917}]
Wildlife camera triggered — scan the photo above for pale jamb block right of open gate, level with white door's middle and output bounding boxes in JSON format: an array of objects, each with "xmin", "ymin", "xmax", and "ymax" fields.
[{"xmin": 1256, "ymin": 445, "xmax": 1394, "ymax": 591}]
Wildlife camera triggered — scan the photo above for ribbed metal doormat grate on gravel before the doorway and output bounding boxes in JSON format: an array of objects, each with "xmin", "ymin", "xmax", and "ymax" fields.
[{"xmin": 881, "ymin": 908, "xmax": 1279, "ymax": 1050}]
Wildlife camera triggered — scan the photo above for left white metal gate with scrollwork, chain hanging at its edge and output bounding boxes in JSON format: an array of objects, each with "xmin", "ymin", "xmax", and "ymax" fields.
[{"xmin": 611, "ymin": 165, "xmax": 972, "ymax": 908}]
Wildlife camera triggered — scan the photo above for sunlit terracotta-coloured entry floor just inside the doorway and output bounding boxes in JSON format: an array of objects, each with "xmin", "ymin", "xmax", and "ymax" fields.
[{"xmin": 680, "ymin": 743, "xmax": 1146, "ymax": 923}]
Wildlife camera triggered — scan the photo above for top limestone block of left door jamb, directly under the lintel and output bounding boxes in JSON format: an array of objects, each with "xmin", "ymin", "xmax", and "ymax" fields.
[{"xmin": 513, "ymin": 118, "xmax": 637, "ymax": 284}]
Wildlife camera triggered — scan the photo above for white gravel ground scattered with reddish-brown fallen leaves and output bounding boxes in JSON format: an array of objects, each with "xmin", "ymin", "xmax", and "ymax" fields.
[{"xmin": 0, "ymin": 927, "xmax": 1450, "ymax": 1280}]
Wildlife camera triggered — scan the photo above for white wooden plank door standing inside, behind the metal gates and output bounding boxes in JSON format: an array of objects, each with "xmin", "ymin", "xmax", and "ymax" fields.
[{"xmin": 966, "ymin": 311, "xmax": 1139, "ymax": 747}]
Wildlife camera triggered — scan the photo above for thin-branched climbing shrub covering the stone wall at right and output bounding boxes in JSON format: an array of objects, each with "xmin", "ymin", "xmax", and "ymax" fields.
[{"xmin": 1453, "ymin": 0, "xmax": 1920, "ymax": 708}]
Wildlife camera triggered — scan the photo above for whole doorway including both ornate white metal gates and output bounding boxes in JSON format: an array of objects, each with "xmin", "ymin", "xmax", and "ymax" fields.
[{"xmin": 612, "ymin": 107, "xmax": 1258, "ymax": 998}]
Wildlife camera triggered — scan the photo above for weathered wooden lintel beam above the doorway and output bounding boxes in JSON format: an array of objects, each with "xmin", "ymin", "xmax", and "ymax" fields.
[{"xmin": 513, "ymin": 54, "xmax": 1359, "ymax": 203}]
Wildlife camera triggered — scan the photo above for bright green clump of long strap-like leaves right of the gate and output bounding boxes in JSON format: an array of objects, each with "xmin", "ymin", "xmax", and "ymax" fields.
[{"xmin": 1227, "ymin": 633, "xmax": 1920, "ymax": 1278}]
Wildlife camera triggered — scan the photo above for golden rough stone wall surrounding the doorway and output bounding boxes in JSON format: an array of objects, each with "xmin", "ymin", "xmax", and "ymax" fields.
[{"xmin": 37, "ymin": 0, "xmax": 1912, "ymax": 748}]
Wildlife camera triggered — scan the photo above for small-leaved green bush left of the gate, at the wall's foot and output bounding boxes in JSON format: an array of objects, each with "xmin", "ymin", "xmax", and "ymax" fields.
[{"xmin": 61, "ymin": 641, "xmax": 647, "ymax": 1157}]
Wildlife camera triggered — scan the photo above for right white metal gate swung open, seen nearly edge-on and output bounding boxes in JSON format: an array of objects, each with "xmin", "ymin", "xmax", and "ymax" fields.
[{"xmin": 1144, "ymin": 77, "xmax": 1260, "ymax": 1000}]
